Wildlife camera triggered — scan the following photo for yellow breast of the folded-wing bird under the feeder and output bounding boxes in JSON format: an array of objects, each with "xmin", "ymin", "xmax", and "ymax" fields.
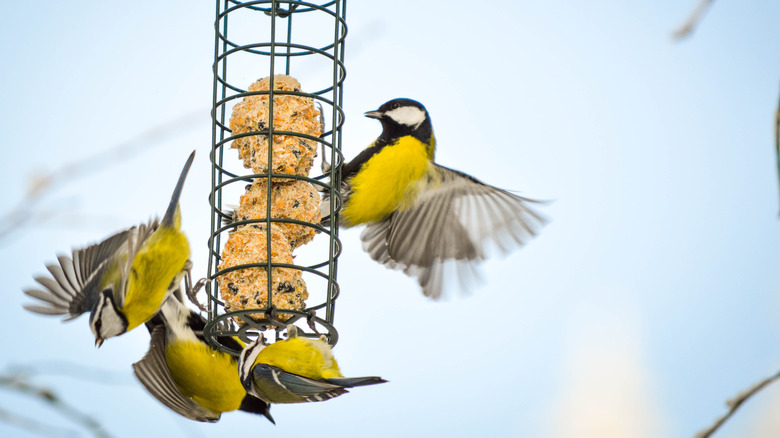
[{"xmin": 255, "ymin": 337, "xmax": 343, "ymax": 380}]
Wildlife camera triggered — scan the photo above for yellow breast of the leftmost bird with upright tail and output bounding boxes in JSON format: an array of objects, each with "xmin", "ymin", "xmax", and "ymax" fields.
[{"xmin": 122, "ymin": 228, "xmax": 190, "ymax": 331}]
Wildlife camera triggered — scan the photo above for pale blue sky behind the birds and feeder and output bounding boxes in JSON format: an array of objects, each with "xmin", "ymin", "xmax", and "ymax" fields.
[{"xmin": 0, "ymin": 0, "xmax": 780, "ymax": 438}]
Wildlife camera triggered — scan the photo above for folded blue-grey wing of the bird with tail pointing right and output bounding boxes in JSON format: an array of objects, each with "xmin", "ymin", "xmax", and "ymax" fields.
[{"xmin": 252, "ymin": 363, "xmax": 347, "ymax": 403}]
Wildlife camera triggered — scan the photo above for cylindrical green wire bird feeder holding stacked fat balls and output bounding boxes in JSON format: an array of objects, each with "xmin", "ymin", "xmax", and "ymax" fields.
[{"xmin": 203, "ymin": 0, "xmax": 347, "ymax": 355}]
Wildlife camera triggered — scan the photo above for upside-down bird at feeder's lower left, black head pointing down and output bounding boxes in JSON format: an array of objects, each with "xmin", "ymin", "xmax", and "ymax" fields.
[{"xmin": 133, "ymin": 295, "xmax": 275, "ymax": 424}]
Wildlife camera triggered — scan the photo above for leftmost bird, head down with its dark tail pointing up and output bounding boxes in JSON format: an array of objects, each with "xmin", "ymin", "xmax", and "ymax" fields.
[{"xmin": 24, "ymin": 151, "xmax": 195, "ymax": 347}]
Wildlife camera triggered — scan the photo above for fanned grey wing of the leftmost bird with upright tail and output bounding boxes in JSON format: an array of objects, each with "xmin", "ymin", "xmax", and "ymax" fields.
[{"xmin": 24, "ymin": 229, "xmax": 133, "ymax": 320}]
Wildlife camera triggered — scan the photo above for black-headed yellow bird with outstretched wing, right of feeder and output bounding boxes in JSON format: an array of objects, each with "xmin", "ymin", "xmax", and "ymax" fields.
[{"xmin": 320, "ymin": 99, "xmax": 544, "ymax": 299}]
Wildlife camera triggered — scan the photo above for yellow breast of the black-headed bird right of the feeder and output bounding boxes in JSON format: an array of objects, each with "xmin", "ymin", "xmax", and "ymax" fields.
[{"xmin": 342, "ymin": 136, "xmax": 431, "ymax": 225}]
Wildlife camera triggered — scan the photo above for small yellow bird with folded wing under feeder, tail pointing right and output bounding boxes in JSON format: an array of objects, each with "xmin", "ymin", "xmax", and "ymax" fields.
[{"xmin": 238, "ymin": 325, "xmax": 386, "ymax": 403}]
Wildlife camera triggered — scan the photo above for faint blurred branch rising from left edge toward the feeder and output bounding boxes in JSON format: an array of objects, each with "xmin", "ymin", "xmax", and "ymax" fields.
[{"xmin": 0, "ymin": 110, "xmax": 205, "ymax": 242}]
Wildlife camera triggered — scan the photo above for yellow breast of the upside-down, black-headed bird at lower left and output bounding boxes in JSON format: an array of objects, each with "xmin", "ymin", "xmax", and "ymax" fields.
[{"xmin": 165, "ymin": 342, "xmax": 246, "ymax": 412}]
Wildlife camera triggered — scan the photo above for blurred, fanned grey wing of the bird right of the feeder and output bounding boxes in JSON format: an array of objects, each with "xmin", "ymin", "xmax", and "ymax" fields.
[{"xmin": 361, "ymin": 165, "xmax": 545, "ymax": 298}]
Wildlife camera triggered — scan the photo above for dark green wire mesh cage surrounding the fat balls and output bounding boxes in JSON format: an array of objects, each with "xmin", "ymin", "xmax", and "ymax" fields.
[{"xmin": 204, "ymin": 0, "xmax": 347, "ymax": 355}]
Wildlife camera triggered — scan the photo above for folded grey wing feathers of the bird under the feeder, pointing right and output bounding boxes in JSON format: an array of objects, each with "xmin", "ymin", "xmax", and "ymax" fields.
[{"xmin": 252, "ymin": 363, "xmax": 348, "ymax": 403}]
